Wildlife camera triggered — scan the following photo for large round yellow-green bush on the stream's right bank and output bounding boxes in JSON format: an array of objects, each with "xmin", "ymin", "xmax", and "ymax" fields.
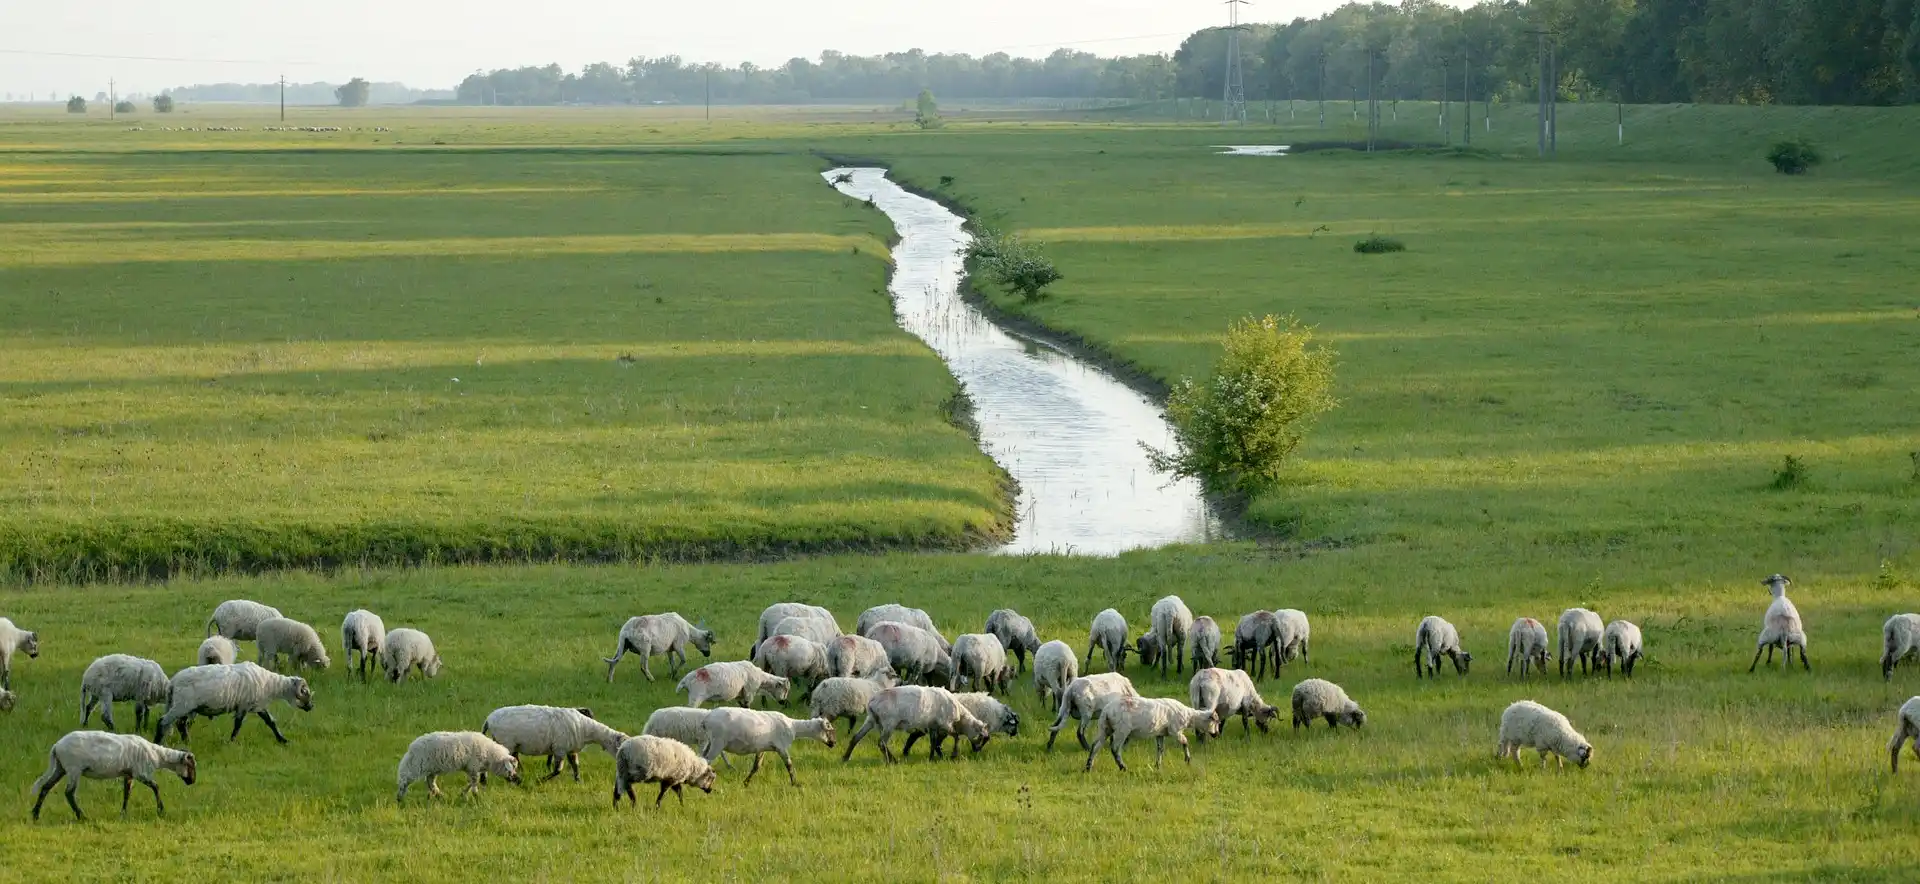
[{"xmin": 1142, "ymin": 315, "xmax": 1338, "ymax": 492}]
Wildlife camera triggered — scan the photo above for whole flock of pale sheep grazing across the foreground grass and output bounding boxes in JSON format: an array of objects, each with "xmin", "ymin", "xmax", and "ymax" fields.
[{"xmin": 0, "ymin": 575, "xmax": 1920, "ymax": 819}]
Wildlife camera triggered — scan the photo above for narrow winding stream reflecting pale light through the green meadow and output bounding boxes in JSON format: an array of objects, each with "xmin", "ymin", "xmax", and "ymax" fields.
[{"xmin": 826, "ymin": 169, "xmax": 1219, "ymax": 555}]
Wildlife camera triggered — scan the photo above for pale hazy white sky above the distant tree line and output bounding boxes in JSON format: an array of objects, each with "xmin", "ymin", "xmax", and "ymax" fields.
[{"xmin": 0, "ymin": 0, "xmax": 1420, "ymax": 98}]
